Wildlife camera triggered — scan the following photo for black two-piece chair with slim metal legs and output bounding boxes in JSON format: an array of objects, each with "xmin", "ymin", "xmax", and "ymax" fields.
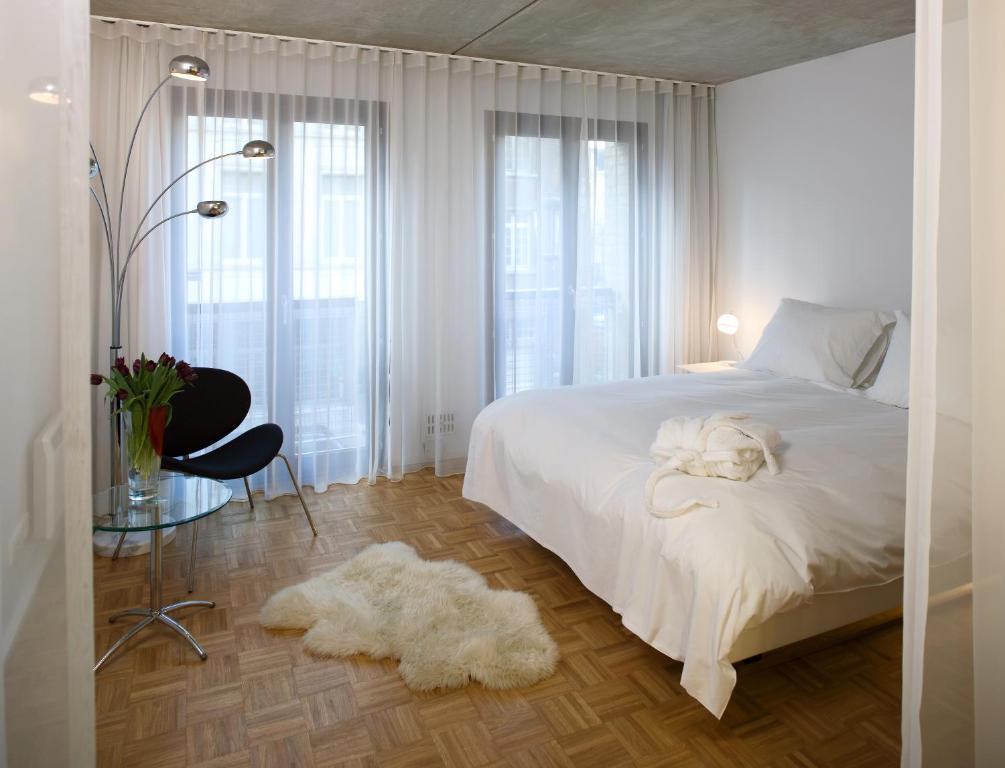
[{"xmin": 117, "ymin": 368, "xmax": 318, "ymax": 592}]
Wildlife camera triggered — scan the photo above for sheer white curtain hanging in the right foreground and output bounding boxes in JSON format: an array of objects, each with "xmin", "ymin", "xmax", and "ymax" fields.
[{"xmin": 902, "ymin": 0, "xmax": 1005, "ymax": 766}]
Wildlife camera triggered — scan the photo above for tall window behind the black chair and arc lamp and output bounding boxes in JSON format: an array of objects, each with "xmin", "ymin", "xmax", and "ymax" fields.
[{"xmin": 173, "ymin": 87, "xmax": 386, "ymax": 477}]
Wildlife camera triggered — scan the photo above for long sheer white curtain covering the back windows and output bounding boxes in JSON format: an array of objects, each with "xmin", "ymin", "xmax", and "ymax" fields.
[{"xmin": 86, "ymin": 19, "xmax": 717, "ymax": 494}]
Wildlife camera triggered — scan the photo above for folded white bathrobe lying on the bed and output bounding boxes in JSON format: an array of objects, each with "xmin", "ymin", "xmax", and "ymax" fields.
[{"xmin": 645, "ymin": 413, "xmax": 782, "ymax": 518}]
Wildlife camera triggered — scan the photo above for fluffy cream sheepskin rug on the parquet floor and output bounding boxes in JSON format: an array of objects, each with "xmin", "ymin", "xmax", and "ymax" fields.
[{"xmin": 261, "ymin": 542, "xmax": 559, "ymax": 691}]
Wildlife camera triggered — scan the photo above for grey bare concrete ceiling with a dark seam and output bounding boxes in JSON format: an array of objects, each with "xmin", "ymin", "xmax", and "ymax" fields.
[{"xmin": 91, "ymin": 0, "xmax": 915, "ymax": 83}]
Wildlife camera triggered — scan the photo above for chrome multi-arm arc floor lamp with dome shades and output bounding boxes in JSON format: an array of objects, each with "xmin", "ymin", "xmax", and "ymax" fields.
[{"xmin": 90, "ymin": 54, "xmax": 275, "ymax": 486}]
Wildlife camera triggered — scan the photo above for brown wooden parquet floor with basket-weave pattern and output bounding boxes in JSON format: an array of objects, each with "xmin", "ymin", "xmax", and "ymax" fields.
[{"xmin": 94, "ymin": 472, "xmax": 900, "ymax": 768}]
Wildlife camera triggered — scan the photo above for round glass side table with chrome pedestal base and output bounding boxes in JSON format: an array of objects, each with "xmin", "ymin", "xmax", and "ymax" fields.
[{"xmin": 91, "ymin": 474, "xmax": 233, "ymax": 673}]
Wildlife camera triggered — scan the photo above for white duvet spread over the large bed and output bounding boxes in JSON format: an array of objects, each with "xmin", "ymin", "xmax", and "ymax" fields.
[{"xmin": 463, "ymin": 369, "xmax": 908, "ymax": 717}]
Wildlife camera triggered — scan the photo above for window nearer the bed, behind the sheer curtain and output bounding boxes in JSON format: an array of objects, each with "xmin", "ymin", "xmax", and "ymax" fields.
[{"xmin": 489, "ymin": 113, "xmax": 645, "ymax": 396}]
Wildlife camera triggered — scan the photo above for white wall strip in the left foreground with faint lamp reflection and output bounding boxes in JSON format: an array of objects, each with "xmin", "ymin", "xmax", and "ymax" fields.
[{"xmin": 0, "ymin": 0, "xmax": 94, "ymax": 768}]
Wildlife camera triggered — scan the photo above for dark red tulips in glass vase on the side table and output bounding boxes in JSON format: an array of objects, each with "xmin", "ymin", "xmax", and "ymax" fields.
[{"xmin": 90, "ymin": 352, "xmax": 199, "ymax": 502}]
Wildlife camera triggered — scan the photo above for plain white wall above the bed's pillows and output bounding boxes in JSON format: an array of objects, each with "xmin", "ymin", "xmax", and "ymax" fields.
[{"xmin": 716, "ymin": 35, "xmax": 915, "ymax": 357}]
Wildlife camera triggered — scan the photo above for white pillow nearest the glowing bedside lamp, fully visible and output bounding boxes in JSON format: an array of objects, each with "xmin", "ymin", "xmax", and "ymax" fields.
[{"xmin": 739, "ymin": 299, "xmax": 894, "ymax": 387}]
